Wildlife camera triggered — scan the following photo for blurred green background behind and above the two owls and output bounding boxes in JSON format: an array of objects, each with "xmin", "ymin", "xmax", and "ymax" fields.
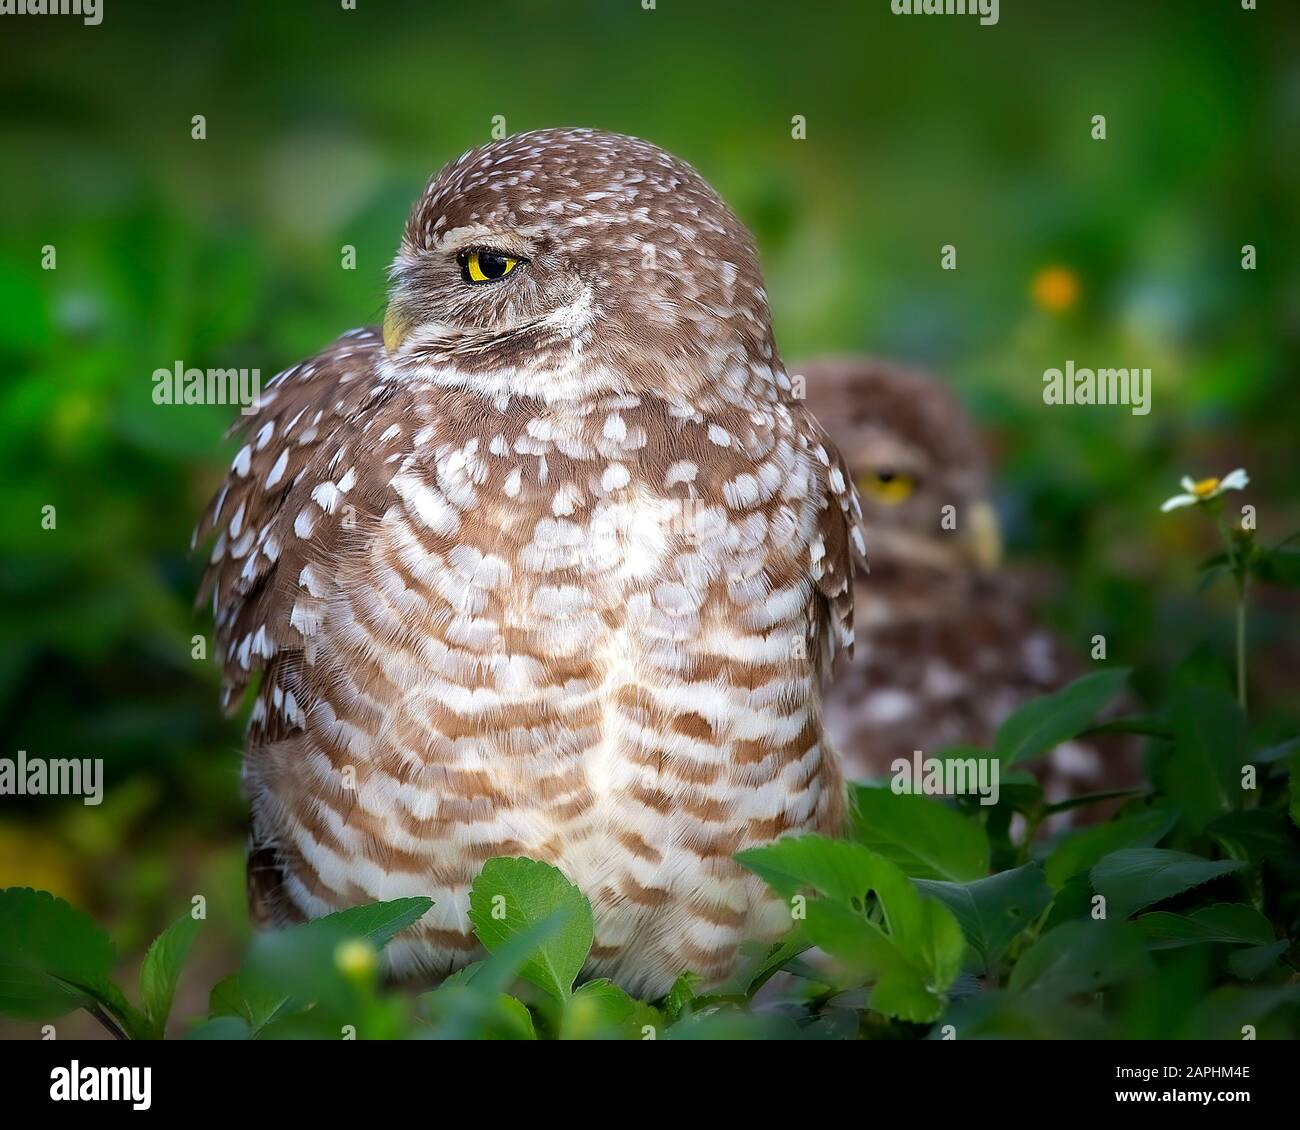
[{"xmin": 0, "ymin": 0, "xmax": 1300, "ymax": 1035}]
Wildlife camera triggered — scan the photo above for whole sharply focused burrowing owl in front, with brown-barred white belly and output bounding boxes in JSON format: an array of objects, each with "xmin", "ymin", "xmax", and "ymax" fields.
[{"xmin": 199, "ymin": 129, "xmax": 862, "ymax": 995}]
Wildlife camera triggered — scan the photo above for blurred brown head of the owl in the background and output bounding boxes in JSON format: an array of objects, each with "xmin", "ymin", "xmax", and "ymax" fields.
[{"xmin": 794, "ymin": 358, "xmax": 1000, "ymax": 577}]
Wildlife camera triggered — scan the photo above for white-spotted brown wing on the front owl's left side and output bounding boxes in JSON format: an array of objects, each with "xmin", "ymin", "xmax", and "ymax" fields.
[{"xmin": 194, "ymin": 329, "xmax": 402, "ymax": 727}]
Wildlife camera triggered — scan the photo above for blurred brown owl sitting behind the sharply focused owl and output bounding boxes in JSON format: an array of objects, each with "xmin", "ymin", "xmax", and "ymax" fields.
[{"xmin": 793, "ymin": 358, "xmax": 1138, "ymax": 802}]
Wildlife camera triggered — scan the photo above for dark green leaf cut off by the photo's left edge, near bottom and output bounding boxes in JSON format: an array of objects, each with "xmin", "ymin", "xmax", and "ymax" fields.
[{"xmin": 0, "ymin": 887, "xmax": 121, "ymax": 1019}]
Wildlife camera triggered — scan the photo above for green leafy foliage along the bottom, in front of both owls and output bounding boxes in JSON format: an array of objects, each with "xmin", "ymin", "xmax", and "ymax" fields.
[{"xmin": 0, "ymin": 644, "xmax": 1300, "ymax": 1040}]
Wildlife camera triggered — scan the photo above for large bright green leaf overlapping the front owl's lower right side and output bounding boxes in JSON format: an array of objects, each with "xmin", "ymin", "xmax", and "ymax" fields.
[{"xmin": 736, "ymin": 836, "xmax": 966, "ymax": 1023}]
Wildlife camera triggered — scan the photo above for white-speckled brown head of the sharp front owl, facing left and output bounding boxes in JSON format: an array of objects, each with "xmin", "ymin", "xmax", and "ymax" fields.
[{"xmin": 384, "ymin": 129, "xmax": 788, "ymax": 401}]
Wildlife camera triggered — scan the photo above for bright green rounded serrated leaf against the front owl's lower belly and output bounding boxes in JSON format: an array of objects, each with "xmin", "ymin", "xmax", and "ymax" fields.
[{"xmin": 469, "ymin": 857, "xmax": 594, "ymax": 1001}]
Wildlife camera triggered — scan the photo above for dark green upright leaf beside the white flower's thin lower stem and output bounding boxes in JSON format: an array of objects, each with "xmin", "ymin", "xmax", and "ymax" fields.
[{"xmin": 1162, "ymin": 687, "xmax": 1245, "ymax": 832}]
